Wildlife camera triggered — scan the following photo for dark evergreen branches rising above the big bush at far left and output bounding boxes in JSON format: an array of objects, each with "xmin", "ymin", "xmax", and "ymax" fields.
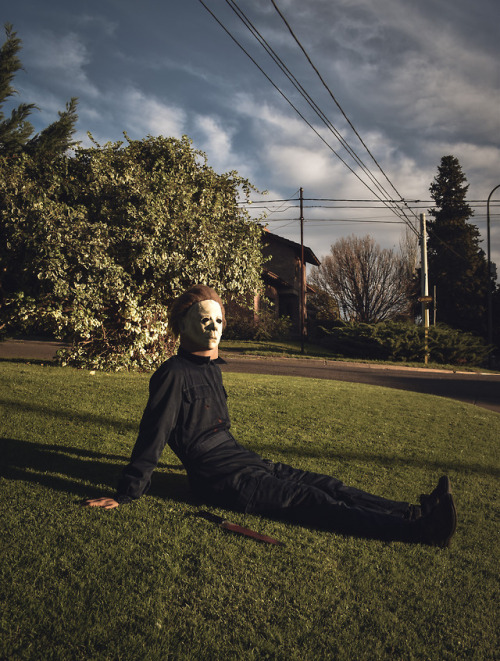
[{"xmin": 0, "ymin": 23, "xmax": 78, "ymax": 158}]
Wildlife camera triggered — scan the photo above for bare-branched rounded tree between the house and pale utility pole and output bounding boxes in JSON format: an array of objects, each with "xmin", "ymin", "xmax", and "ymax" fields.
[{"xmin": 310, "ymin": 235, "xmax": 413, "ymax": 323}]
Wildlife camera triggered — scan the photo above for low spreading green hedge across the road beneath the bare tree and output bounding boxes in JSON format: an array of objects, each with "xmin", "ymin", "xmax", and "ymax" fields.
[{"xmin": 320, "ymin": 321, "xmax": 490, "ymax": 365}]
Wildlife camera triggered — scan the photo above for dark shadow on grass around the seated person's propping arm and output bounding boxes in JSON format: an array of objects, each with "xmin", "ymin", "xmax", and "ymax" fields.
[{"xmin": 0, "ymin": 437, "xmax": 189, "ymax": 502}]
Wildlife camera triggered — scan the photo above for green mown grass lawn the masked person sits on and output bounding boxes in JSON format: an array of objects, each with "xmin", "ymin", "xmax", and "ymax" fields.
[{"xmin": 0, "ymin": 361, "xmax": 500, "ymax": 661}]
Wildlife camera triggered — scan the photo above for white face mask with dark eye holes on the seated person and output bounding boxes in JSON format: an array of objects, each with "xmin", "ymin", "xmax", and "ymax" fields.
[{"xmin": 180, "ymin": 300, "xmax": 222, "ymax": 351}]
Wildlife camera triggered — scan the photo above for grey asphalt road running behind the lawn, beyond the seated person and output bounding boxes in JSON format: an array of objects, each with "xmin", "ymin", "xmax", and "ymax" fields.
[{"xmin": 0, "ymin": 340, "xmax": 500, "ymax": 413}]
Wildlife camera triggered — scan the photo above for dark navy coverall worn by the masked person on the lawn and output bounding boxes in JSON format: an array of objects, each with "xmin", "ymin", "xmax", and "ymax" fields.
[{"xmin": 115, "ymin": 348, "xmax": 419, "ymax": 541}]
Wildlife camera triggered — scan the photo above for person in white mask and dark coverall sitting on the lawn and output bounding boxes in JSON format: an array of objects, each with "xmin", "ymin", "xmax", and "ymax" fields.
[{"xmin": 85, "ymin": 285, "xmax": 456, "ymax": 547}]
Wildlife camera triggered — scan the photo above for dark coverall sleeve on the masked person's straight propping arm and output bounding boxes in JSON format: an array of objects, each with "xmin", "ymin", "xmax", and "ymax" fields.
[{"xmin": 115, "ymin": 366, "xmax": 183, "ymax": 504}]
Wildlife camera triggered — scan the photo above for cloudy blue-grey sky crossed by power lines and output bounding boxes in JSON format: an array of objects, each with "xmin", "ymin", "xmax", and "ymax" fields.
[{"xmin": 2, "ymin": 0, "xmax": 500, "ymax": 265}]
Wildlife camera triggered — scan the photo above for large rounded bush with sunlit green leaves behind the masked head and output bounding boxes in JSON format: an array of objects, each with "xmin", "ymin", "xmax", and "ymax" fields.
[{"xmin": 0, "ymin": 137, "xmax": 262, "ymax": 369}]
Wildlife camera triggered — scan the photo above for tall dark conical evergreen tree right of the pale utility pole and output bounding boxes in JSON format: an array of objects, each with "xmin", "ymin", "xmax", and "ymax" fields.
[{"xmin": 427, "ymin": 156, "xmax": 489, "ymax": 334}]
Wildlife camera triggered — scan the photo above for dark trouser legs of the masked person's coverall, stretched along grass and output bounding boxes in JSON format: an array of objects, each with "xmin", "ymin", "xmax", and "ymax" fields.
[{"xmin": 202, "ymin": 461, "xmax": 419, "ymax": 542}]
